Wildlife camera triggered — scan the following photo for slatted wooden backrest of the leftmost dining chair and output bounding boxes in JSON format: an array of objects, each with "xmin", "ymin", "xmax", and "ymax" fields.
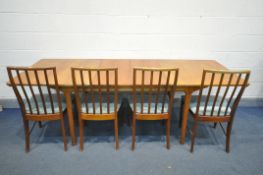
[{"xmin": 7, "ymin": 67, "xmax": 62, "ymax": 115}]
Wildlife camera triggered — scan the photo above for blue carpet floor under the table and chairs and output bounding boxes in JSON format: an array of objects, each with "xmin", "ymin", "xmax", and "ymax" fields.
[{"xmin": 0, "ymin": 107, "xmax": 263, "ymax": 175}]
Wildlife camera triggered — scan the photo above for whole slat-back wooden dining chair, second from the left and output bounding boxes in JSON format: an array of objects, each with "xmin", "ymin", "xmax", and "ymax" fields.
[{"xmin": 71, "ymin": 68, "xmax": 119, "ymax": 151}]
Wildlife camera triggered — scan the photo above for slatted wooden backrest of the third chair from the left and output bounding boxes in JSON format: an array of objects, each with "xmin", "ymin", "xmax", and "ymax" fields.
[{"xmin": 133, "ymin": 68, "xmax": 179, "ymax": 114}]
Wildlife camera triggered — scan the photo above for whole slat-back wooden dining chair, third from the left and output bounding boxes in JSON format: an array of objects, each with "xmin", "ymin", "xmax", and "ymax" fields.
[{"xmin": 132, "ymin": 68, "xmax": 179, "ymax": 150}]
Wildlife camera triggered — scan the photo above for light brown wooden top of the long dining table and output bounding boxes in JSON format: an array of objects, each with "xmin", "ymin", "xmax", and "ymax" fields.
[{"xmin": 25, "ymin": 59, "xmax": 227, "ymax": 88}]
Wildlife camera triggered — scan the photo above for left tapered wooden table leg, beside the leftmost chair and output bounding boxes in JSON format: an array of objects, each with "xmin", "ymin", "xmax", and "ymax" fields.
[{"xmin": 64, "ymin": 90, "xmax": 76, "ymax": 145}]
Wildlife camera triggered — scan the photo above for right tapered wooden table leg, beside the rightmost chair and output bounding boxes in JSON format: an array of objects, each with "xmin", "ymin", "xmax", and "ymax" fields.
[{"xmin": 180, "ymin": 91, "xmax": 192, "ymax": 144}]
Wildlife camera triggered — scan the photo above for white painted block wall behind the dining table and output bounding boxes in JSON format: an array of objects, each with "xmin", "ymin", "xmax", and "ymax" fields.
[{"xmin": 0, "ymin": 0, "xmax": 263, "ymax": 99}]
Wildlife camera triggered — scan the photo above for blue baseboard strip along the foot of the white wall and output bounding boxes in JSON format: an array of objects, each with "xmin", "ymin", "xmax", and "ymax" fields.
[{"xmin": 0, "ymin": 97, "xmax": 263, "ymax": 108}]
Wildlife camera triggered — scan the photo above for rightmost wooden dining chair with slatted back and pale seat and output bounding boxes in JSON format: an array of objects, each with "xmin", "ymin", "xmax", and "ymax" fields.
[{"xmin": 190, "ymin": 70, "xmax": 250, "ymax": 152}]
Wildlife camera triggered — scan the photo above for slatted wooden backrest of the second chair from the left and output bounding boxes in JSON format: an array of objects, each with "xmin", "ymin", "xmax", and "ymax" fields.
[{"xmin": 71, "ymin": 68, "xmax": 118, "ymax": 114}]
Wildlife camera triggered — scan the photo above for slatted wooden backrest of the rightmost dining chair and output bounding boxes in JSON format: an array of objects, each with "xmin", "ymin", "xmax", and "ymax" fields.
[{"xmin": 196, "ymin": 70, "xmax": 250, "ymax": 116}]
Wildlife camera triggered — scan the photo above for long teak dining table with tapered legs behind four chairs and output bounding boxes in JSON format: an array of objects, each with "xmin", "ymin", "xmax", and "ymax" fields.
[{"xmin": 10, "ymin": 59, "xmax": 227, "ymax": 145}]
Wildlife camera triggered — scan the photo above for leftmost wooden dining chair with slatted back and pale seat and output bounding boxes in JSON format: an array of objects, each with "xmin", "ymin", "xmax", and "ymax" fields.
[{"xmin": 7, "ymin": 67, "xmax": 67, "ymax": 152}]
